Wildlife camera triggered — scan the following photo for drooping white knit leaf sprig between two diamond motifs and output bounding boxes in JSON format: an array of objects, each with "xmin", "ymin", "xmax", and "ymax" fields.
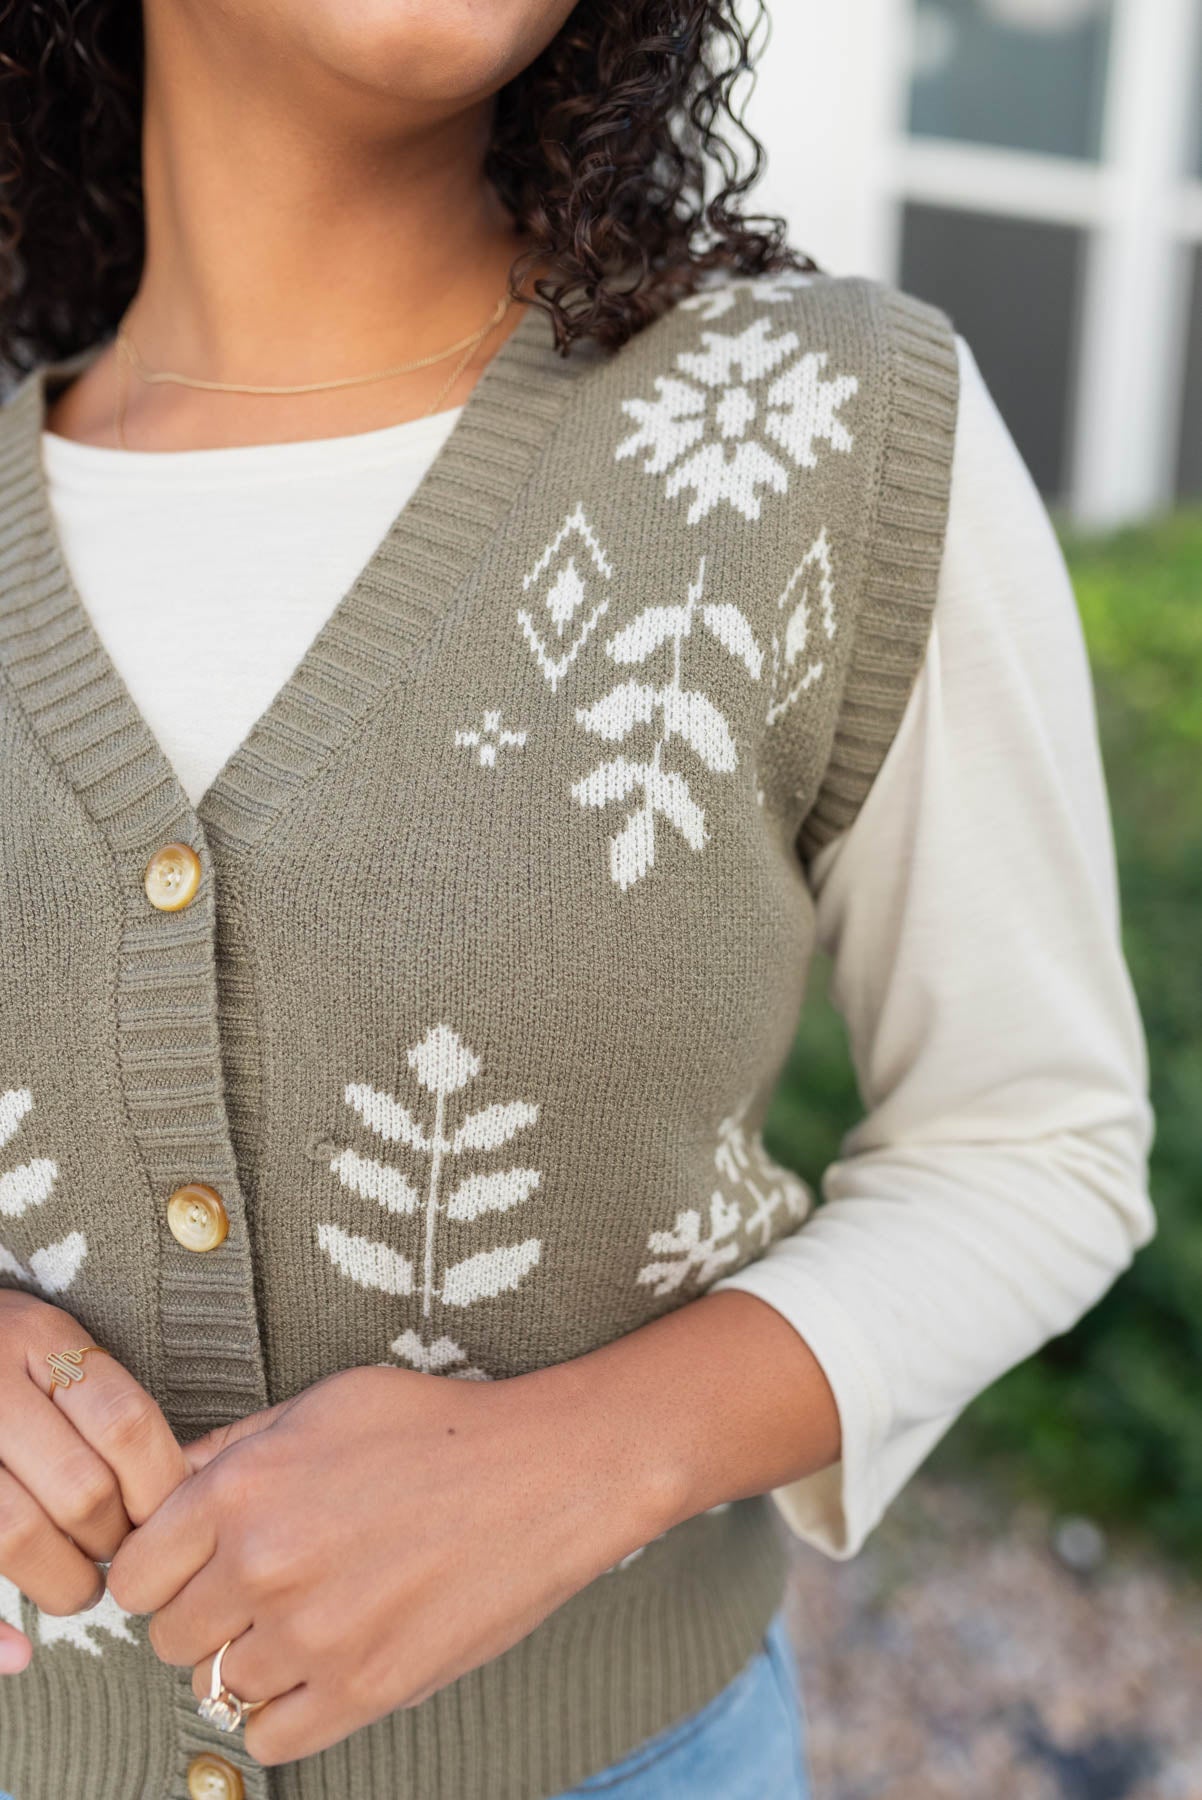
[{"xmin": 572, "ymin": 556, "xmax": 763, "ymax": 891}]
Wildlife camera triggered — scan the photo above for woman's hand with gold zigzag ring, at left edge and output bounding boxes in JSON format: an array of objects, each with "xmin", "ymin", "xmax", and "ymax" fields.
[{"xmin": 0, "ymin": 1289, "xmax": 189, "ymax": 1674}]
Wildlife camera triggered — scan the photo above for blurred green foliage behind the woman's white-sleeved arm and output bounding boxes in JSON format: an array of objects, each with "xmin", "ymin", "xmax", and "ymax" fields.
[{"xmin": 765, "ymin": 511, "xmax": 1202, "ymax": 1570}]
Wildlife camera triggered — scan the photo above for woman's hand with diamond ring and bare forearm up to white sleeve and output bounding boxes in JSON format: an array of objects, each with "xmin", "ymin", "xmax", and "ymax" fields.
[{"xmin": 108, "ymin": 1292, "xmax": 839, "ymax": 1764}]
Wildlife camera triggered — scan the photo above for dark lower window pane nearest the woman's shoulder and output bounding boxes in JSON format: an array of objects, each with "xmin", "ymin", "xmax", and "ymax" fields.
[{"xmin": 900, "ymin": 205, "xmax": 1085, "ymax": 499}]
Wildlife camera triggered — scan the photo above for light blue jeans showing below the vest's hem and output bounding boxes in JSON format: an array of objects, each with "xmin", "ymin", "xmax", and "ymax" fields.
[{"xmin": 560, "ymin": 1613, "xmax": 810, "ymax": 1800}]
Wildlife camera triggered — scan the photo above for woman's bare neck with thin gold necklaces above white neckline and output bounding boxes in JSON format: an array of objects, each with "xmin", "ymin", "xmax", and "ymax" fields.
[{"xmin": 47, "ymin": 5, "xmax": 522, "ymax": 450}]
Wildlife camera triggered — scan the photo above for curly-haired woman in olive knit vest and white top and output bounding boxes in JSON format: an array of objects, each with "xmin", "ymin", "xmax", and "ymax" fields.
[{"xmin": 0, "ymin": 0, "xmax": 1153, "ymax": 1800}]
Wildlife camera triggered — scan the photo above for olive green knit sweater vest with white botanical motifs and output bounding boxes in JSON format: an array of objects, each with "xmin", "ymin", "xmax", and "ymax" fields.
[{"xmin": 0, "ymin": 275, "xmax": 957, "ymax": 1800}]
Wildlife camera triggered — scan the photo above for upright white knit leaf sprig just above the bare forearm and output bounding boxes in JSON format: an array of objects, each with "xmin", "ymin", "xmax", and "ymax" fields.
[{"xmin": 317, "ymin": 1024, "xmax": 542, "ymax": 1379}]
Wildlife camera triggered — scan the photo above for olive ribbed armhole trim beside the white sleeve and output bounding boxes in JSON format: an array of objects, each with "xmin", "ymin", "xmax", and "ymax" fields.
[{"xmin": 799, "ymin": 286, "xmax": 959, "ymax": 857}]
